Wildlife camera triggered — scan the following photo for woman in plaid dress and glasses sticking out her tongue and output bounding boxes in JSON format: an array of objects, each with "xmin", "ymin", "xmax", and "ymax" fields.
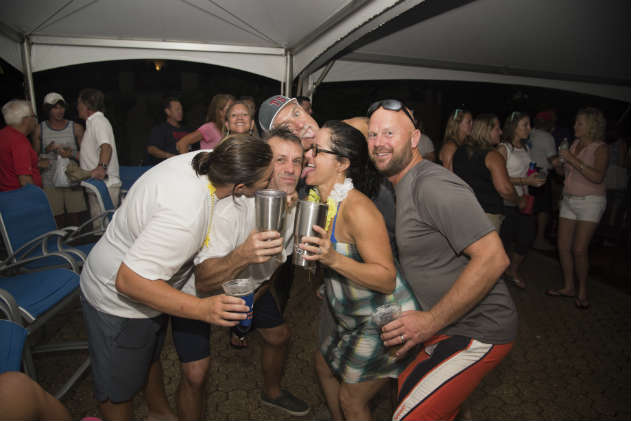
[{"xmin": 301, "ymin": 121, "xmax": 418, "ymax": 420}]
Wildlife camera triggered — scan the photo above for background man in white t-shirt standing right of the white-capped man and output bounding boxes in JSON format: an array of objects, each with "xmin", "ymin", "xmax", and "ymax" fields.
[{"xmin": 77, "ymin": 88, "xmax": 121, "ymax": 225}]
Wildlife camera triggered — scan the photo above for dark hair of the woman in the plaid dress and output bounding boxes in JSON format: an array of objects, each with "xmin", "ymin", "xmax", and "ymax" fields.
[{"xmin": 322, "ymin": 120, "xmax": 382, "ymax": 198}]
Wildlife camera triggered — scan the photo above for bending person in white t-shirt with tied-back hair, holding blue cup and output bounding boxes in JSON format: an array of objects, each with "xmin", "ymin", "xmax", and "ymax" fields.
[{"xmin": 80, "ymin": 137, "xmax": 272, "ymax": 419}]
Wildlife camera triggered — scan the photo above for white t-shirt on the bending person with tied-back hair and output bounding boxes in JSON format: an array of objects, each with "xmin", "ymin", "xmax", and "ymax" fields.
[{"xmin": 81, "ymin": 152, "xmax": 211, "ymax": 318}]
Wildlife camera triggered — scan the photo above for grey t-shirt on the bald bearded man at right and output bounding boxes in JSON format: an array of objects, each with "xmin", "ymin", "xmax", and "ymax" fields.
[{"xmin": 396, "ymin": 160, "xmax": 517, "ymax": 344}]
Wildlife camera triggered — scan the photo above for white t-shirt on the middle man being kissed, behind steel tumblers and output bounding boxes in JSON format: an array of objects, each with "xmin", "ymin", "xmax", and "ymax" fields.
[{"xmin": 182, "ymin": 196, "xmax": 296, "ymax": 295}]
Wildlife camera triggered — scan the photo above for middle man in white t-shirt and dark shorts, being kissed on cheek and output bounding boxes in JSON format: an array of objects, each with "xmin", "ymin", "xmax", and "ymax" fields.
[{"xmin": 173, "ymin": 129, "xmax": 310, "ymax": 419}]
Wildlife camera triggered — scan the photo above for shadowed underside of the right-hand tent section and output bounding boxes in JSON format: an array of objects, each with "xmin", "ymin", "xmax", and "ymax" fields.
[{"xmin": 311, "ymin": 0, "xmax": 631, "ymax": 101}]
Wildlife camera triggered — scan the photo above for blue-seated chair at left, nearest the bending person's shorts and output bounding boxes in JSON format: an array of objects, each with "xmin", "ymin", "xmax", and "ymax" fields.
[{"xmin": 0, "ymin": 251, "xmax": 90, "ymax": 399}]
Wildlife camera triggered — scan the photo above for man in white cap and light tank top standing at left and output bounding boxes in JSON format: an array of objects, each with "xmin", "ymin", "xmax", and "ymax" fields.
[{"xmin": 33, "ymin": 92, "xmax": 87, "ymax": 227}]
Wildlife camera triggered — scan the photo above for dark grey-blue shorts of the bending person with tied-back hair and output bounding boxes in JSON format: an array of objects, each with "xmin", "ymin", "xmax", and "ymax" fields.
[{"xmin": 81, "ymin": 294, "xmax": 169, "ymax": 403}]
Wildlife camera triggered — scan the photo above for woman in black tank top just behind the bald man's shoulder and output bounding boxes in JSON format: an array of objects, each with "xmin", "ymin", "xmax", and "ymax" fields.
[{"xmin": 453, "ymin": 114, "xmax": 525, "ymax": 232}]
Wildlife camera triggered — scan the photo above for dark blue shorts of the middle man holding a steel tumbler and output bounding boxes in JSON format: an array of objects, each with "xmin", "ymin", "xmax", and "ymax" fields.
[{"xmin": 171, "ymin": 289, "xmax": 285, "ymax": 363}]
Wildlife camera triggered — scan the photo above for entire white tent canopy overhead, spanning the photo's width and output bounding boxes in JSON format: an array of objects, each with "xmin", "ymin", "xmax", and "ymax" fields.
[{"xmin": 0, "ymin": 0, "xmax": 631, "ymax": 102}]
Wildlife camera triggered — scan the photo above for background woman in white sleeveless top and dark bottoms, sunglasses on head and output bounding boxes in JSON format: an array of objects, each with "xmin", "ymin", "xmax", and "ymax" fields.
[{"xmin": 497, "ymin": 111, "xmax": 546, "ymax": 289}]
